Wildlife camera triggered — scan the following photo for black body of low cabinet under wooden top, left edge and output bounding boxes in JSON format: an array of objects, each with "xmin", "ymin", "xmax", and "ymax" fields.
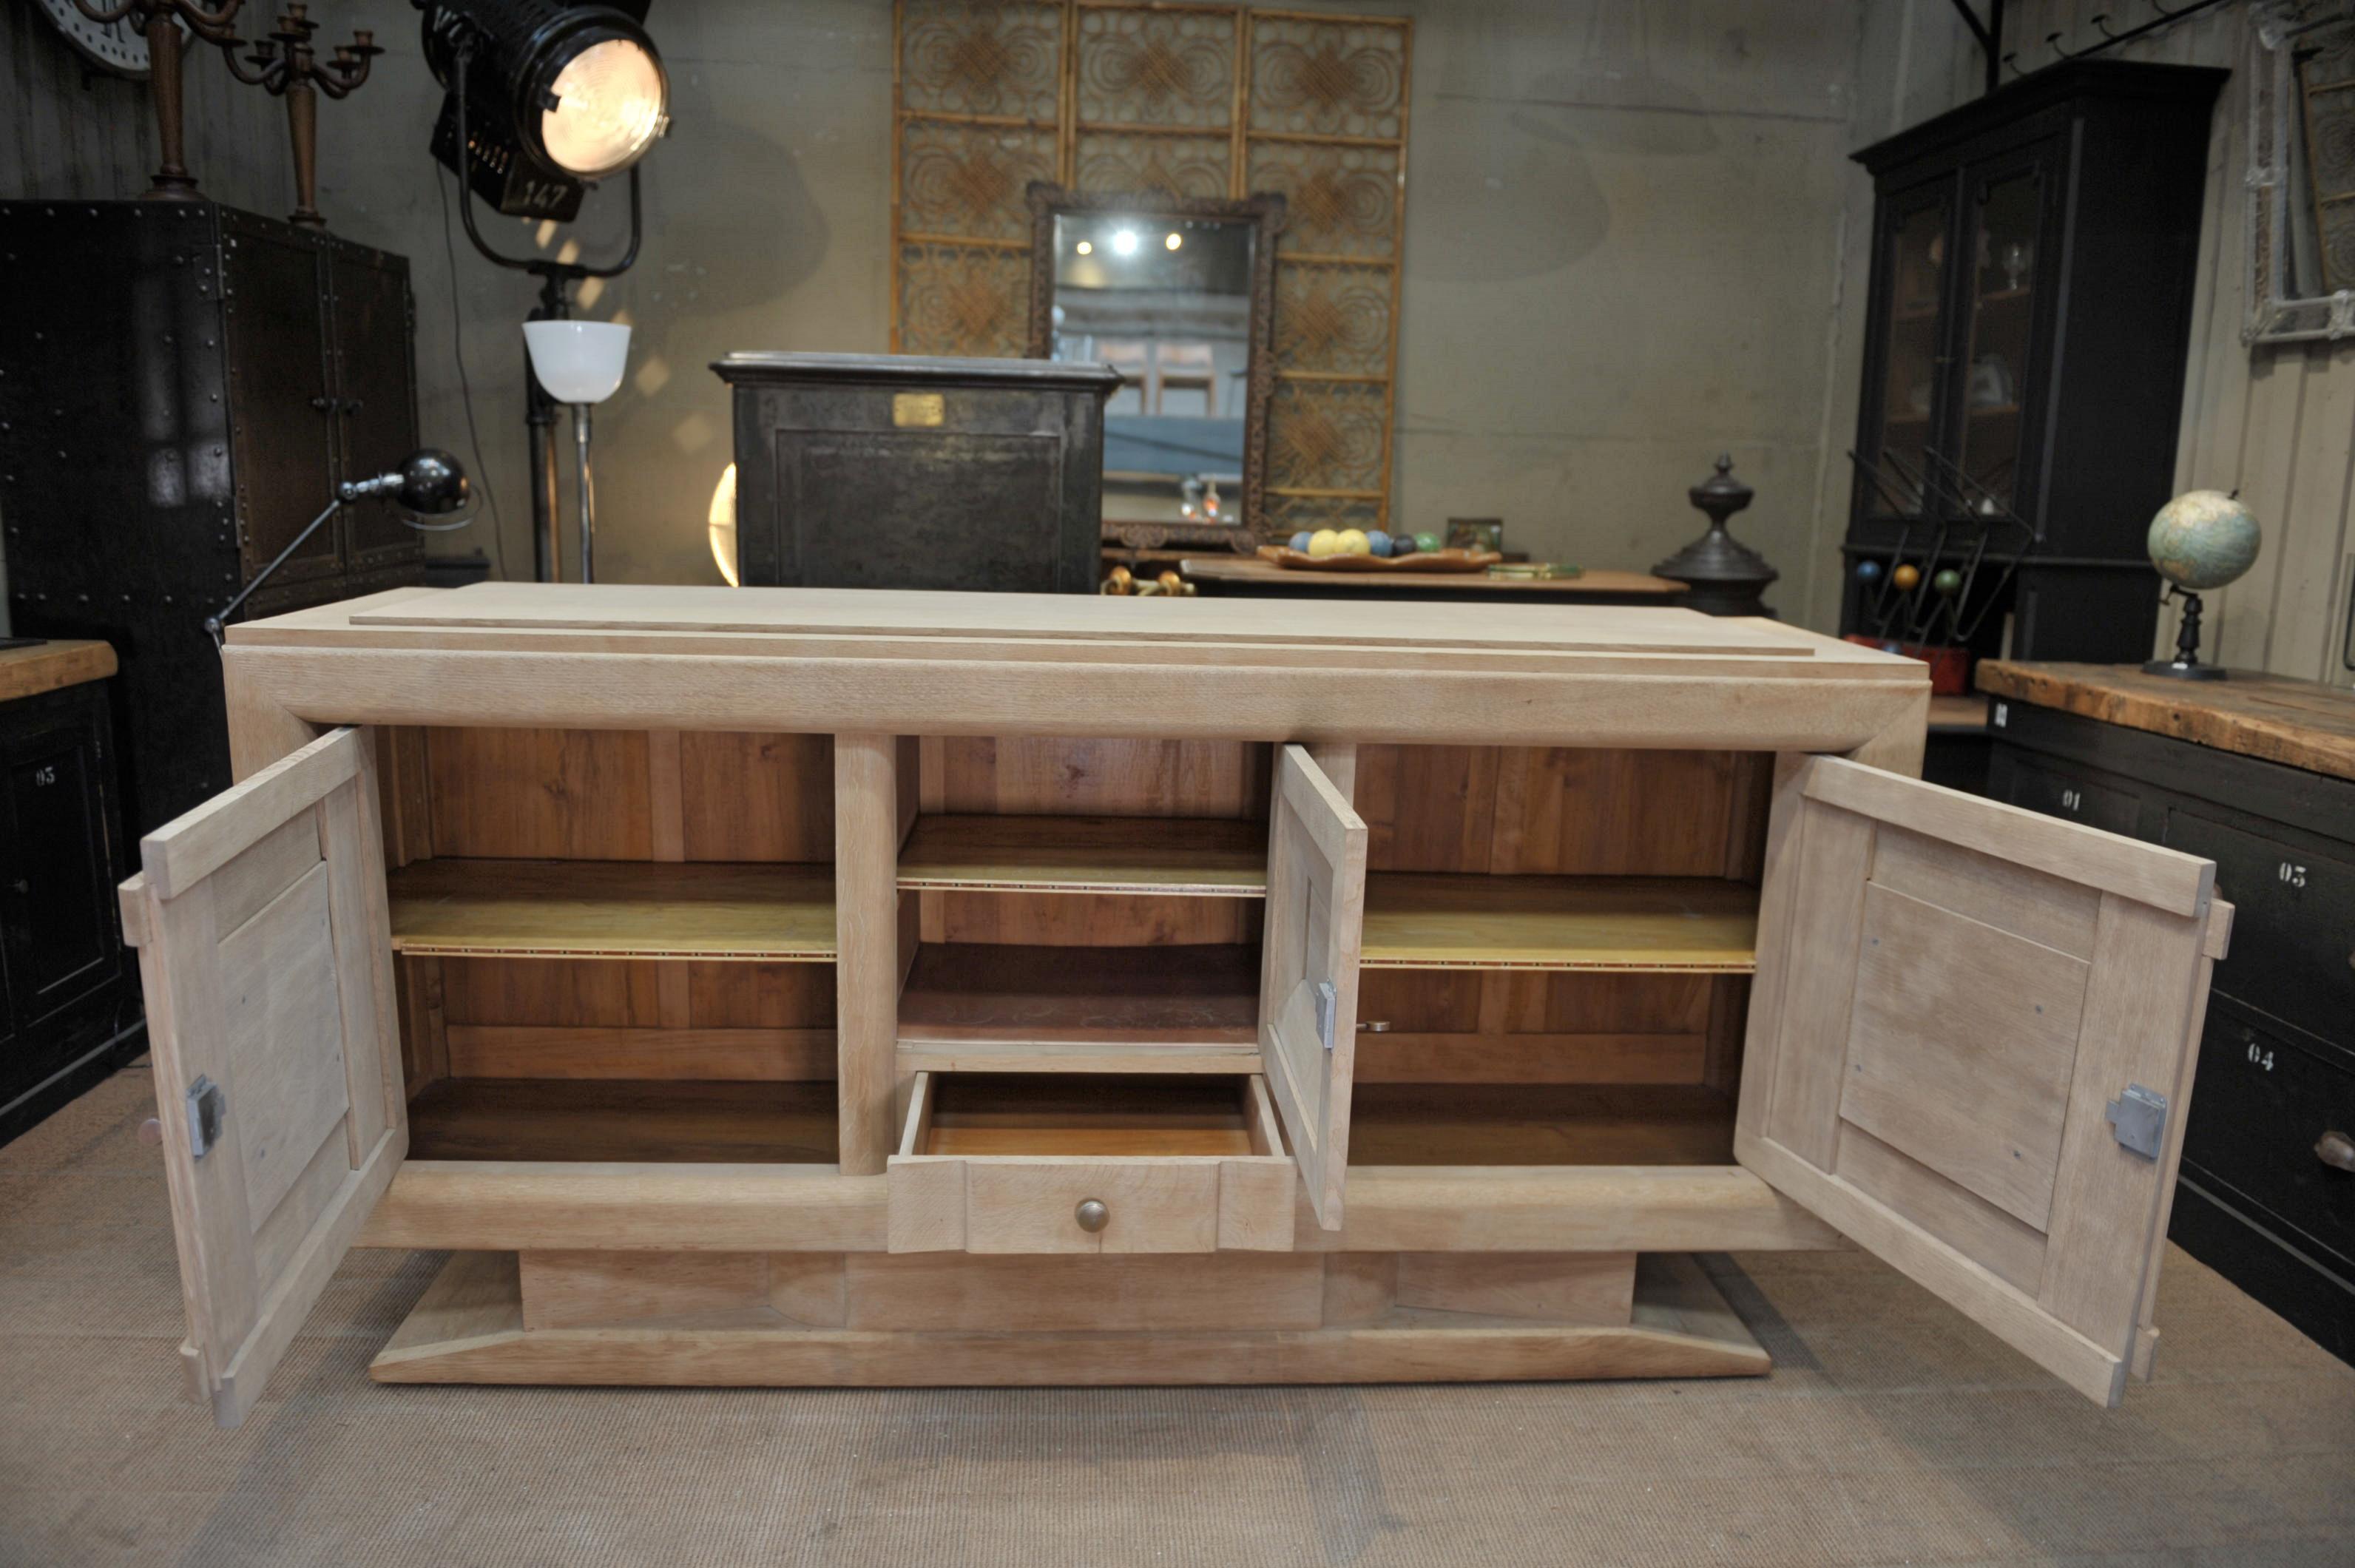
[{"xmin": 0, "ymin": 683, "xmax": 139, "ymax": 1142}]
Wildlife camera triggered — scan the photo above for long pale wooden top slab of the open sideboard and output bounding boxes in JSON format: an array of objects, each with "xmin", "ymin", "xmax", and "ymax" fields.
[{"xmin": 212, "ymin": 584, "xmax": 1929, "ymax": 751}]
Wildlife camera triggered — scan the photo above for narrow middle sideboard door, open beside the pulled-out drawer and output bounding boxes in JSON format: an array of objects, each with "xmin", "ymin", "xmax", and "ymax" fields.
[{"xmin": 1260, "ymin": 746, "xmax": 1366, "ymax": 1231}]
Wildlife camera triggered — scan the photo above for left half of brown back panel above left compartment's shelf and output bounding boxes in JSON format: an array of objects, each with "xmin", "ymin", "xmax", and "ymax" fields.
[{"xmin": 426, "ymin": 728, "xmax": 655, "ymax": 859}]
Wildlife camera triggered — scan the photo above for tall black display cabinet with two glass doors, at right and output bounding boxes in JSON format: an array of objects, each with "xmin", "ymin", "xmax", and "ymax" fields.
[{"xmin": 1842, "ymin": 61, "xmax": 2226, "ymax": 664}]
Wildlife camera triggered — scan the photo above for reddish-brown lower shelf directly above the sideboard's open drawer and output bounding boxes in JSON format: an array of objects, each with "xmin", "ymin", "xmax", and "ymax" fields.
[{"xmin": 899, "ymin": 942, "xmax": 1260, "ymax": 1074}]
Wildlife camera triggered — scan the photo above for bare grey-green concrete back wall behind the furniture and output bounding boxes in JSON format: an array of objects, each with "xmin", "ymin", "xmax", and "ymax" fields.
[{"xmin": 0, "ymin": 0, "xmax": 1884, "ymax": 624}]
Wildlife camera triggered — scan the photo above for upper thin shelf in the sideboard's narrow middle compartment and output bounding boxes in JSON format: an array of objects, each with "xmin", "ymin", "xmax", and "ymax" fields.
[{"xmin": 899, "ymin": 817, "xmax": 1267, "ymax": 899}]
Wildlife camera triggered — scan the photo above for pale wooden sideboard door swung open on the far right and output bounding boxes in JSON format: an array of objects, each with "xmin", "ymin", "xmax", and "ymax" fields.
[{"xmin": 1736, "ymin": 758, "xmax": 2232, "ymax": 1405}]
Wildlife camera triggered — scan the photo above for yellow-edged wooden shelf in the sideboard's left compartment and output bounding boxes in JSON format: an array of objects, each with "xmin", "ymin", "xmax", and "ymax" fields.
[{"xmin": 386, "ymin": 859, "xmax": 834, "ymax": 963}]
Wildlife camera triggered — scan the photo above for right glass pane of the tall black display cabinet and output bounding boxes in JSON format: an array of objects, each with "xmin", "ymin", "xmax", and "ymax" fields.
[{"xmin": 1955, "ymin": 163, "xmax": 2047, "ymax": 513}]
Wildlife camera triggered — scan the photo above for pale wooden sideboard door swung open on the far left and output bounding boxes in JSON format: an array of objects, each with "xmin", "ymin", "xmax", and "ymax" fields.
[{"xmin": 123, "ymin": 730, "xmax": 410, "ymax": 1427}]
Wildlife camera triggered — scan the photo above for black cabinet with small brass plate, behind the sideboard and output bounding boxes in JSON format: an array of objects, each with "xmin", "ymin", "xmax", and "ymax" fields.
[{"xmin": 714, "ymin": 353, "xmax": 1121, "ymax": 593}]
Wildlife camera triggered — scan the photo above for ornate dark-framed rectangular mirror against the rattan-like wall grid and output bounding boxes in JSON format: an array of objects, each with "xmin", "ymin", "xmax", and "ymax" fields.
[{"xmin": 1029, "ymin": 183, "xmax": 1283, "ymax": 551}]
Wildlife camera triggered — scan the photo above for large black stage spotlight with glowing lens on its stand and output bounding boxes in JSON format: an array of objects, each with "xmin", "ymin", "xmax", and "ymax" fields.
[{"xmin": 414, "ymin": 0, "xmax": 671, "ymax": 581}]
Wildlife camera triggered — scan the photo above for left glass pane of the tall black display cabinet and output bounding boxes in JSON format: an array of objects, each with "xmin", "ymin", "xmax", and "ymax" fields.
[{"xmin": 1865, "ymin": 179, "xmax": 1955, "ymax": 518}]
